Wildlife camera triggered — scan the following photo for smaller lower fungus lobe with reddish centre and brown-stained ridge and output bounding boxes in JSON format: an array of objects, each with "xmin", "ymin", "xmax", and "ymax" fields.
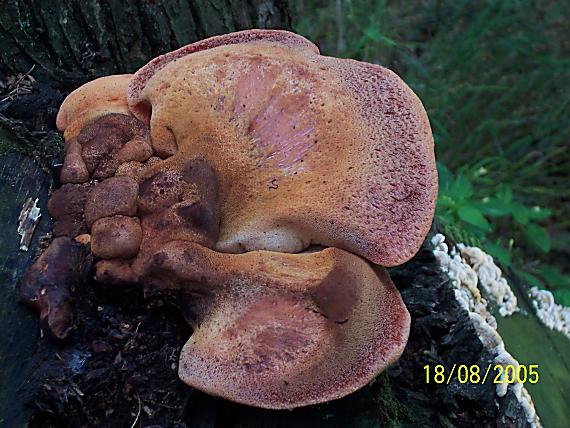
[{"xmin": 142, "ymin": 241, "xmax": 410, "ymax": 409}]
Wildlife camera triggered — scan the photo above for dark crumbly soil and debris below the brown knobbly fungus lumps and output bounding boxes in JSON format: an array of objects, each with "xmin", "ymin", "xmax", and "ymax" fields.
[{"xmin": 25, "ymin": 284, "xmax": 191, "ymax": 427}]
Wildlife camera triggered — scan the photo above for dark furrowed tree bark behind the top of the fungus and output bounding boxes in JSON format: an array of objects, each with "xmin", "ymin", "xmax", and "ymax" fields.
[{"xmin": 0, "ymin": 0, "xmax": 291, "ymax": 90}]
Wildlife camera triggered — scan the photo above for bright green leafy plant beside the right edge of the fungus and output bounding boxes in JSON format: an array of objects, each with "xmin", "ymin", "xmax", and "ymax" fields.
[{"xmin": 436, "ymin": 163, "xmax": 570, "ymax": 305}]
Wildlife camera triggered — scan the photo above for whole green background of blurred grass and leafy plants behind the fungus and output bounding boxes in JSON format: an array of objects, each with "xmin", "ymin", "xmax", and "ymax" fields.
[{"xmin": 297, "ymin": 0, "xmax": 570, "ymax": 305}]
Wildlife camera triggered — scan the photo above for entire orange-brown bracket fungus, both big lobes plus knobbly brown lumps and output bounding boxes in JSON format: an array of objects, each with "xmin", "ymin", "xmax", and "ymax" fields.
[{"xmin": 18, "ymin": 30, "xmax": 437, "ymax": 409}]
